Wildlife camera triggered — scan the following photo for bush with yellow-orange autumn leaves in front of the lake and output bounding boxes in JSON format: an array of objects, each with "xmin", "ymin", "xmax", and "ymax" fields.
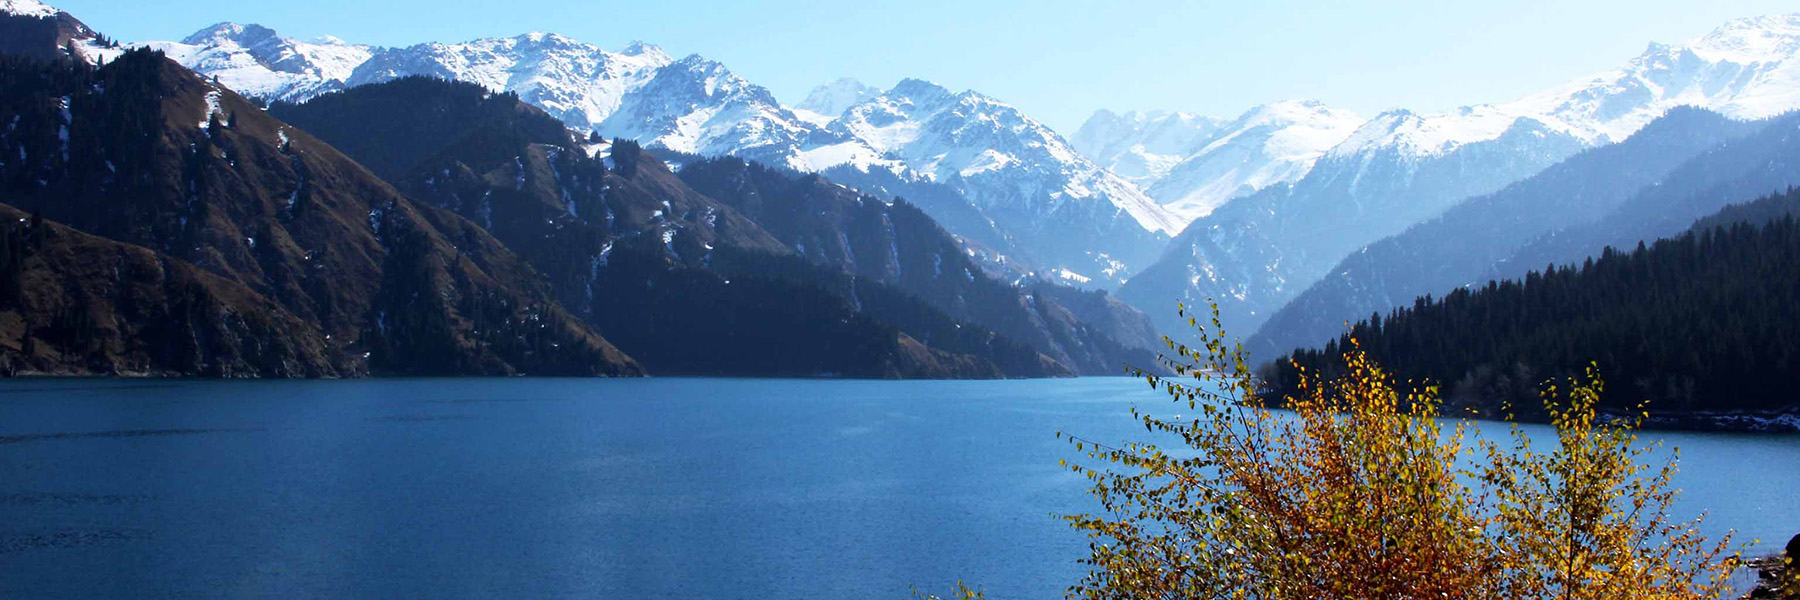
[{"xmin": 1066, "ymin": 300, "xmax": 1735, "ymax": 598}]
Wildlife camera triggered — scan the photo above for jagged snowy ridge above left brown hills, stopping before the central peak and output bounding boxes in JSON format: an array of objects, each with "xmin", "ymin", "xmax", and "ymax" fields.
[{"xmin": 146, "ymin": 23, "xmax": 821, "ymax": 162}]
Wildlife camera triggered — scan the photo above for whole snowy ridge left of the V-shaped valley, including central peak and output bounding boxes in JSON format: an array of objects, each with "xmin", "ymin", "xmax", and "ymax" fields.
[{"xmin": 149, "ymin": 23, "xmax": 1184, "ymax": 285}]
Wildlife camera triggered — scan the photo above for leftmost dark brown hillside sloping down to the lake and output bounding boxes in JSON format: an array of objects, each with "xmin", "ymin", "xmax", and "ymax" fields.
[{"xmin": 0, "ymin": 50, "xmax": 641, "ymax": 375}]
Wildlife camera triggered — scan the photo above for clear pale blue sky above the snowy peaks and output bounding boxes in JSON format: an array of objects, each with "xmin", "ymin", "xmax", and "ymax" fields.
[{"xmin": 47, "ymin": 0, "xmax": 1800, "ymax": 133}]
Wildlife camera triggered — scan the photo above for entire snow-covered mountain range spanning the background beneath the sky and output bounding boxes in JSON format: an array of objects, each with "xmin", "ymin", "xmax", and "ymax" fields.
[{"xmin": 136, "ymin": 16, "xmax": 1800, "ymax": 322}]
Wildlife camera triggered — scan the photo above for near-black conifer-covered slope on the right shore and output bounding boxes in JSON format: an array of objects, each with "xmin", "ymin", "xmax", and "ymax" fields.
[{"xmin": 1264, "ymin": 189, "xmax": 1800, "ymax": 418}]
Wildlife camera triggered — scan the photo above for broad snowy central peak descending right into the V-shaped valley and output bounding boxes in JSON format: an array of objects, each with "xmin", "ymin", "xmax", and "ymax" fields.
[{"xmin": 801, "ymin": 79, "xmax": 1181, "ymax": 285}]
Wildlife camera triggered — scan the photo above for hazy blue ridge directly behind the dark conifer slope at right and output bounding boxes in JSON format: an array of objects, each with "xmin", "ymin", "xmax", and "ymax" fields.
[{"xmin": 1249, "ymin": 108, "xmax": 1800, "ymax": 351}]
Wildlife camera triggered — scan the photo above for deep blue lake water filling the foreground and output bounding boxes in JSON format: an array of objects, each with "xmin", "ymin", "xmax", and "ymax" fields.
[{"xmin": 0, "ymin": 378, "xmax": 1800, "ymax": 600}]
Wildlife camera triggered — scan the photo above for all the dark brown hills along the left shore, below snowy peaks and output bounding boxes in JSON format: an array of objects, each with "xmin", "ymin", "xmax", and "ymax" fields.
[{"xmin": 0, "ymin": 0, "xmax": 1156, "ymax": 378}]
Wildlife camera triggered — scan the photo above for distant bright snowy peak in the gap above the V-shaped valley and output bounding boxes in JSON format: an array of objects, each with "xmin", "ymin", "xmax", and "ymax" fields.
[{"xmin": 1075, "ymin": 101, "xmax": 1363, "ymax": 222}]
